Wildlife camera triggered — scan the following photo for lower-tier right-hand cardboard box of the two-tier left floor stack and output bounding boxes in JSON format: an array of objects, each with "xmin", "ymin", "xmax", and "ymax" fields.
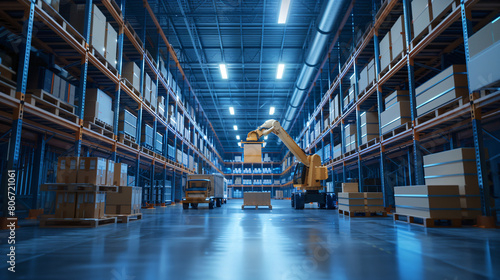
[{"xmin": 75, "ymin": 192, "xmax": 106, "ymax": 219}]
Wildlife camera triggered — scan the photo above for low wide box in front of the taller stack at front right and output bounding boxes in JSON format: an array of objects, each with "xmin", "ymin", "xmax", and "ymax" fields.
[{"xmin": 394, "ymin": 185, "xmax": 461, "ymax": 219}]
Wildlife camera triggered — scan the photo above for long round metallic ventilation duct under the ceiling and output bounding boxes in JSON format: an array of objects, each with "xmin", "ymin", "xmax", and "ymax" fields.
[{"xmin": 283, "ymin": 0, "xmax": 352, "ymax": 130}]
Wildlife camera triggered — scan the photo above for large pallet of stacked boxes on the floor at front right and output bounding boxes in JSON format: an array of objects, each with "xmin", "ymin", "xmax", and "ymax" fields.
[{"xmin": 394, "ymin": 148, "xmax": 493, "ymax": 227}]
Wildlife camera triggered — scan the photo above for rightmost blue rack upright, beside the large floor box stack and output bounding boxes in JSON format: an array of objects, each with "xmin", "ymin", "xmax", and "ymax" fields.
[{"xmin": 460, "ymin": 0, "xmax": 494, "ymax": 217}]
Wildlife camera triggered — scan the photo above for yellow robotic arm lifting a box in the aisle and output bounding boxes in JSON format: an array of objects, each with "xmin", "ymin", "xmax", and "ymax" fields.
[{"xmin": 247, "ymin": 120, "xmax": 328, "ymax": 190}]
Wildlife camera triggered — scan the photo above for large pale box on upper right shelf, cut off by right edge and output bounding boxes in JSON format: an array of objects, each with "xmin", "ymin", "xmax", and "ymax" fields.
[{"xmin": 469, "ymin": 19, "xmax": 500, "ymax": 91}]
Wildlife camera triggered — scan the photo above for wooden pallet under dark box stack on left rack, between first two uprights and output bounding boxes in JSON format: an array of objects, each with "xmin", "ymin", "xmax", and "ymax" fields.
[{"xmin": 24, "ymin": 92, "xmax": 78, "ymax": 123}]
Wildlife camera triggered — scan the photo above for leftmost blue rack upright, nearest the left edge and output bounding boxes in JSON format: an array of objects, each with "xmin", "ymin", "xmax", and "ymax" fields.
[{"xmin": 0, "ymin": 1, "xmax": 35, "ymax": 217}]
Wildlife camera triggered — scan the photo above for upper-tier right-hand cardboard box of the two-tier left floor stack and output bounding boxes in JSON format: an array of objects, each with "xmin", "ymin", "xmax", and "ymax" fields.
[{"xmin": 77, "ymin": 157, "xmax": 106, "ymax": 186}]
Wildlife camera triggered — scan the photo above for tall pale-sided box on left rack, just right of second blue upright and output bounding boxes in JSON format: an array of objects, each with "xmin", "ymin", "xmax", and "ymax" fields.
[{"xmin": 84, "ymin": 88, "xmax": 114, "ymax": 126}]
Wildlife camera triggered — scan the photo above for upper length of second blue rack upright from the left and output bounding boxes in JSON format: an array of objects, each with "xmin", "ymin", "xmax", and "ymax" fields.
[{"xmin": 75, "ymin": 0, "xmax": 92, "ymax": 157}]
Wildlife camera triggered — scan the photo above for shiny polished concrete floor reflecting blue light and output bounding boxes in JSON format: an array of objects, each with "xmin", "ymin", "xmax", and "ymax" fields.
[{"xmin": 0, "ymin": 200, "xmax": 500, "ymax": 280}]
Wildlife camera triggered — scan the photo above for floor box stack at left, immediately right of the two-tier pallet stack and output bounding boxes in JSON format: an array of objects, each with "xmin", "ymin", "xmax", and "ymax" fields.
[{"xmin": 106, "ymin": 186, "xmax": 142, "ymax": 215}]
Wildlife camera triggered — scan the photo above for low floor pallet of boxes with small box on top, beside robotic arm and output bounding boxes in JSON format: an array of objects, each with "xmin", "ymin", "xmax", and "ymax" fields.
[{"xmin": 338, "ymin": 183, "xmax": 387, "ymax": 217}]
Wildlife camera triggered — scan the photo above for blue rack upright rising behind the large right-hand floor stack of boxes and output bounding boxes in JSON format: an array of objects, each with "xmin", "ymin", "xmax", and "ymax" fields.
[{"xmin": 403, "ymin": 0, "xmax": 425, "ymax": 185}]
